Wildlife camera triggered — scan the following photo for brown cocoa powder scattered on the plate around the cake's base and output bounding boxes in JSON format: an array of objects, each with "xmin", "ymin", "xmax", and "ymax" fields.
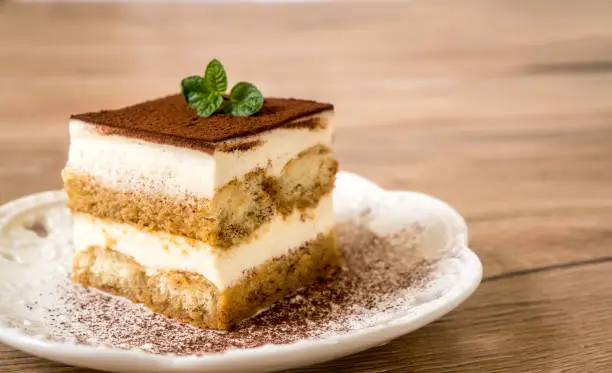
[{"xmin": 44, "ymin": 224, "xmax": 432, "ymax": 355}]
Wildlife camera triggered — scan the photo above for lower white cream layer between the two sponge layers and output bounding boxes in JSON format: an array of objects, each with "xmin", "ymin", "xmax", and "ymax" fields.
[{"xmin": 73, "ymin": 195, "xmax": 334, "ymax": 289}]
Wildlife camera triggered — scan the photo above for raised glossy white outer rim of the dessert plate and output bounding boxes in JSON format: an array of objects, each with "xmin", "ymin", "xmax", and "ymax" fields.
[{"xmin": 0, "ymin": 171, "xmax": 482, "ymax": 372}]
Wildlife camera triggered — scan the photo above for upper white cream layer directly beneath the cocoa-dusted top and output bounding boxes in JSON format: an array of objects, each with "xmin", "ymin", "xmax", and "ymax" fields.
[{"xmin": 66, "ymin": 113, "xmax": 332, "ymax": 198}]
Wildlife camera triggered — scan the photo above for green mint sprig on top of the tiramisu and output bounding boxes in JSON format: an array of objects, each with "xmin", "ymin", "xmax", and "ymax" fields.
[{"xmin": 181, "ymin": 59, "xmax": 264, "ymax": 117}]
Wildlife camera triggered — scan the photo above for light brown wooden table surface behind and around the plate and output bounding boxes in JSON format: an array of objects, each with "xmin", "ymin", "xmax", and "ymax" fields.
[{"xmin": 0, "ymin": 0, "xmax": 612, "ymax": 373}]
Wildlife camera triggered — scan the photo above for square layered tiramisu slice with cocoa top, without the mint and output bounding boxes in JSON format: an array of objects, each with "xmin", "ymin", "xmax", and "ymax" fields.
[{"xmin": 62, "ymin": 94, "xmax": 341, "ymax": 329}]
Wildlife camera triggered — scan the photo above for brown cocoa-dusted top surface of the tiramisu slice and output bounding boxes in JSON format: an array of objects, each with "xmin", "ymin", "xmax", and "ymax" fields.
[{"xmin": 72, "ymin": 94, "xmax": 333, "ymax": 147}]
